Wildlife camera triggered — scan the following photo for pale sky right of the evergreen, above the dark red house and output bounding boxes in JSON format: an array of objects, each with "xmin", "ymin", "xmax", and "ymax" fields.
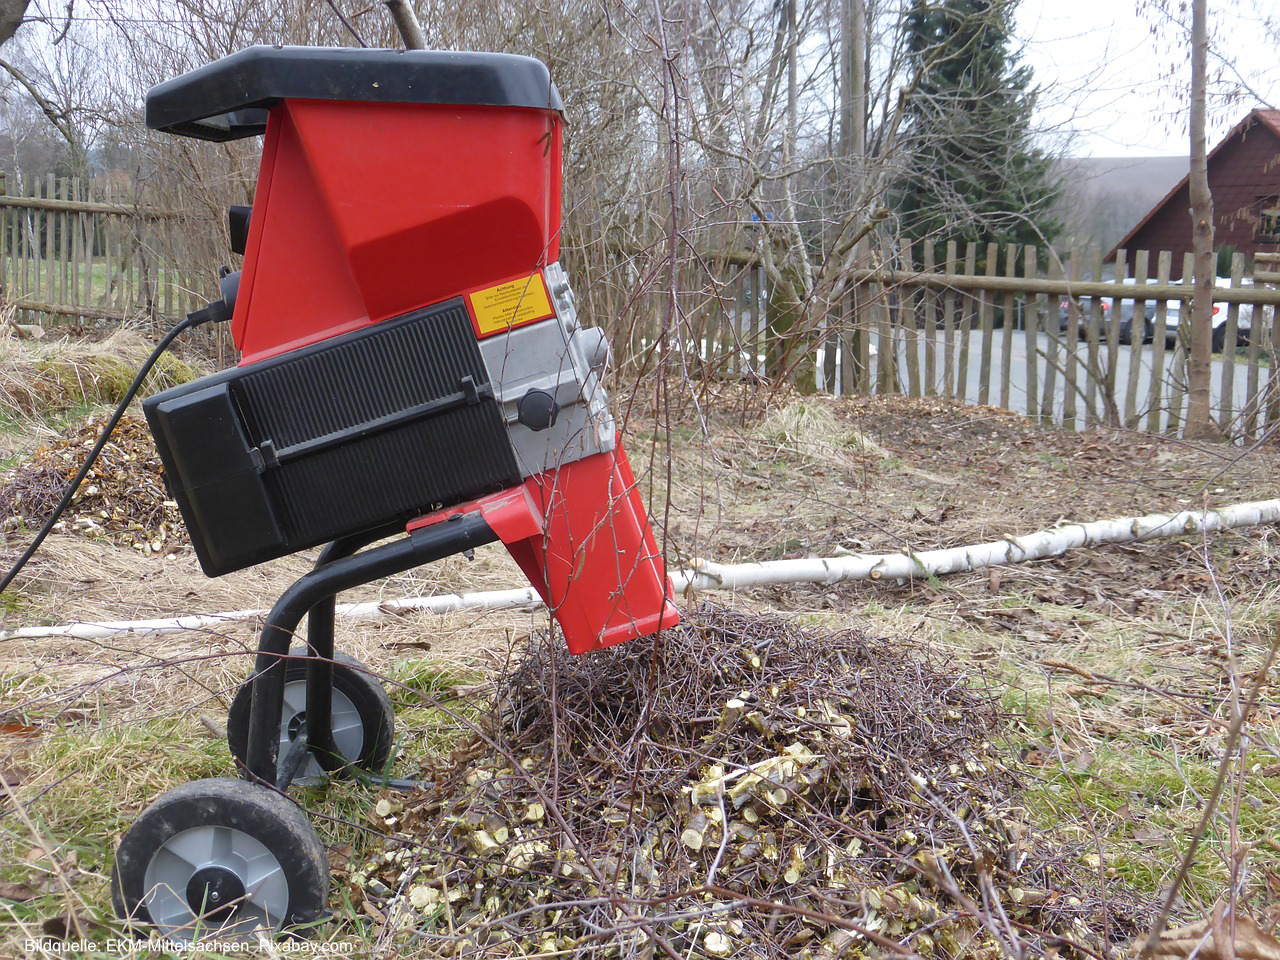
[{"xmin": 1018, "ymin": 0, "xmax": 1280, "ymax": 157}]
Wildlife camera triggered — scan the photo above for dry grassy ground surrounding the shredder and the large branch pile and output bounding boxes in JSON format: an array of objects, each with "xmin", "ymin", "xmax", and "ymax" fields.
[{"xmin": 0, "ymin": 388, "xmax": 1280, "ymax": 957}]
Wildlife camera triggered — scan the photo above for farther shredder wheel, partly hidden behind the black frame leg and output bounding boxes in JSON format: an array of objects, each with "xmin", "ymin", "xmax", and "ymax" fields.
[{"xmin": 227, "ymin": 648, "xmax": 396, "ymax": 785}]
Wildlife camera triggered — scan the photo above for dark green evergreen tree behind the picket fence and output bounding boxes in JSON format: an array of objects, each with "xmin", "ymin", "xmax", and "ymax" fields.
[{"xmin": 895, "ymin": 0, "xmax": 1061, "ymax": 252}]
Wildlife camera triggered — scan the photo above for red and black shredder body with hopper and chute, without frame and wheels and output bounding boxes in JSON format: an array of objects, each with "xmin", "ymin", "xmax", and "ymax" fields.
[{"xmin": 145, "ymin": 47, "xmax": 678, "ymax": 653}]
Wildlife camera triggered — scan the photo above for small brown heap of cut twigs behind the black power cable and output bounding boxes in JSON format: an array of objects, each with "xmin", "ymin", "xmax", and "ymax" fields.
[{"xmin": 0, "ymin": 416, "xmax": 187, "ymax": 556}]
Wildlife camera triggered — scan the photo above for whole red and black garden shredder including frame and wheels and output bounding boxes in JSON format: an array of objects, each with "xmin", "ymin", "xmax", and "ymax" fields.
[{"xmin": 113, "ymin": 46, "xmax": 678, "ymax": 940}]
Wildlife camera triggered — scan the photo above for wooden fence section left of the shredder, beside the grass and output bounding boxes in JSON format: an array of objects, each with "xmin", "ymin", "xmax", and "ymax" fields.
[{"xmin": 0, "ymin": 173, "xmax": 214, "ymax": 324}]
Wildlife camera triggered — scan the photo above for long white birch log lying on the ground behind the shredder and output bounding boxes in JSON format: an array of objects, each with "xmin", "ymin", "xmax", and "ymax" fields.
[{"xmin": 0, "ymin": 499, "xmax": 1280, "ymax": 640}]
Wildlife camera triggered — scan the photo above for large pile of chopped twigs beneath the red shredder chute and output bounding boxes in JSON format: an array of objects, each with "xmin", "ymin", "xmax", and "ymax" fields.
[{"xmin": 348, "ymin": 604, "xmax": 1152, "ymax": 957}]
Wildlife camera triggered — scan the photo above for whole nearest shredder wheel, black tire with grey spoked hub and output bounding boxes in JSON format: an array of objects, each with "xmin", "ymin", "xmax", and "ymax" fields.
[{"xmin": 111, "ymin": 778, "xmax": 329, "ymax": 941}]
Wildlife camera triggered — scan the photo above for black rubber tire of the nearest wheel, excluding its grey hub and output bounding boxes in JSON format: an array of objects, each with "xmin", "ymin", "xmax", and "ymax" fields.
[{"xmin": 111, "ymin": 777, "xmax": 329, "ymax": 940}]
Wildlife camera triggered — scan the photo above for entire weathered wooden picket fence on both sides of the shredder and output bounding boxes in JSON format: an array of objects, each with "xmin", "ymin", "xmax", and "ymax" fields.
[{"xmin": 0, "ymin": 174, "xmax": 1280, "ymax": 440}]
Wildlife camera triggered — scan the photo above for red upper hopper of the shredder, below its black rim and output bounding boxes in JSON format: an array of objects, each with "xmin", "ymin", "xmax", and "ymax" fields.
[{"xmin": 232, "ymin": 100, "xmax": 561, "ymax": 362}]
